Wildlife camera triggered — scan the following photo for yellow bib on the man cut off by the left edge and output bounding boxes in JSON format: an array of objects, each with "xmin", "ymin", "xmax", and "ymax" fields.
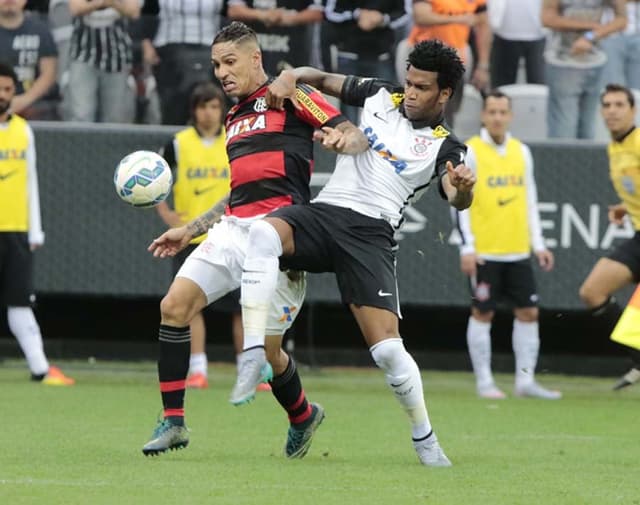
[{"xmin": 0, "ymin": 114, "xmax": 29, "ymax": 232}]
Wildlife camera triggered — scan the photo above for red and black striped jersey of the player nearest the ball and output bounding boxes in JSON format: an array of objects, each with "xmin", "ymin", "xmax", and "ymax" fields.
[{"xmin": 225, "ymin": 83, "xmax": 346, "ymax": 217}]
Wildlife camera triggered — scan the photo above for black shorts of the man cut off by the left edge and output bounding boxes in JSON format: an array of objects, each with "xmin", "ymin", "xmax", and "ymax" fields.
[{"xmin": 0, "ymin": 232, "xmax": 35, "ymax": 307}]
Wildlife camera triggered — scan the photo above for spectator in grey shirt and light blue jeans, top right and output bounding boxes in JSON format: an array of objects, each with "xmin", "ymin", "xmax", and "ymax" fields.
[{"xmin": 542, "ymin": 0, "xmax": 627, "ymax": 139}]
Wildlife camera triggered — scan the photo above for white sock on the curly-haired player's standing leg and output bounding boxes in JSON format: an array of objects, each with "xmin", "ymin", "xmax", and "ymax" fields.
[{"xmin": 369, "ymin": 338, "xmax": 432, "ymax": 440}]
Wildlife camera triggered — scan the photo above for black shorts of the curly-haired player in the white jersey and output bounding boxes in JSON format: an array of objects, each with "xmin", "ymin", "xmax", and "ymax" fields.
[{"xmin": 269, "ymin": 203, "xmax": 400, "ymax": 316}]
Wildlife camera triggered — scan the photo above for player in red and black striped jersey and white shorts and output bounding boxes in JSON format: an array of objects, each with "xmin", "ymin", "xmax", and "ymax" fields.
[{"xmin": 142, "ymin": 22, "xmax": 367, "ymax": 455}]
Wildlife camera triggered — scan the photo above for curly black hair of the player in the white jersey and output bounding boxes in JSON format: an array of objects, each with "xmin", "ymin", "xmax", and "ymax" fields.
[{"xmin": 407, "ymin": 39, "xmax": 464, "ymax": 94}]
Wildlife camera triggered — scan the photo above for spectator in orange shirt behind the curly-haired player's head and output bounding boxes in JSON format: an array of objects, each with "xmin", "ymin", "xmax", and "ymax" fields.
[{"xmin": 408, "ymin": 0, "xmax": 491, "ymax": 127}]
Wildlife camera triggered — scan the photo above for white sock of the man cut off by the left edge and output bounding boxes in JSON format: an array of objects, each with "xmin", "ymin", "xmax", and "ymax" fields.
[{"xmin": 7, "ymin": 307, "xmax": 49, "ymax": 375}]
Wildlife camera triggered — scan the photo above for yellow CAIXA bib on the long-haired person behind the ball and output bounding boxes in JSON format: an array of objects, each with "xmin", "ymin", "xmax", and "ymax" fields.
[{"xmin": 173, "ymin": 127, "xmax": 231, "ymax": 244}]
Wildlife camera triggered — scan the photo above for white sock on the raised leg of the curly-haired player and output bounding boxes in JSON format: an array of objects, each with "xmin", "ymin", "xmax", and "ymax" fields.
[{"xmin": 240, "ymin": 220, "xmax": 282, "ymax": 350}]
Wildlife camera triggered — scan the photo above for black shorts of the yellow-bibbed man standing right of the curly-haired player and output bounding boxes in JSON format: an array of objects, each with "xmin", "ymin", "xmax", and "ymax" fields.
[{"xmin": 470, "ymin": 258, "xmax": 538, "ymax": 312}]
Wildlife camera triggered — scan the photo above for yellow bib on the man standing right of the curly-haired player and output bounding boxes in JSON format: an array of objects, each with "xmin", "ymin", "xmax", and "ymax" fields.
[{"xmin": 467, "ymin": 136, "xmax": 531, "ymax": 255}]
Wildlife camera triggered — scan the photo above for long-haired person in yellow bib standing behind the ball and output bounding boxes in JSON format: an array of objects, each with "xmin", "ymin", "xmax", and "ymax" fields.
[{"xmin": 156, "ymin": 82, "xmax": 252, "ymax": 388}]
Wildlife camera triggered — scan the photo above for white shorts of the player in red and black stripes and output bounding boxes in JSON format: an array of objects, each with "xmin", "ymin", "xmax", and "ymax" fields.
[{"xmin": 176, "ymin": 216, "xmax": 307, "ymax": 335}]
